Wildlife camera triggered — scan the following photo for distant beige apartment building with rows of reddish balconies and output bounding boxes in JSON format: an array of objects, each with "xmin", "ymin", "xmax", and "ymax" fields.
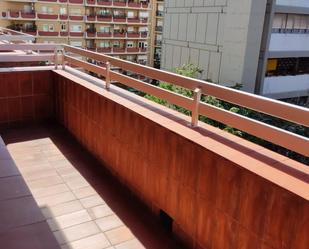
[{"xmin": 0, "ymin": 0, "xmax": 155, "ymax": 64}]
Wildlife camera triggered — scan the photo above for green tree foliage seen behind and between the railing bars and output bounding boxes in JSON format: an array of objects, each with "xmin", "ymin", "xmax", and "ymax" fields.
[{"xmin": 145, "ymin": 64, "xmax": 309, "ymax": 165}]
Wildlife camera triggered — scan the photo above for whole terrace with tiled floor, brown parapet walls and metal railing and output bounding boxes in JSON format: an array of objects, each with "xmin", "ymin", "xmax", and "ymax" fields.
[{"xmin": 0, "ymin": 30, "xmax": 309, "ymax": 249}]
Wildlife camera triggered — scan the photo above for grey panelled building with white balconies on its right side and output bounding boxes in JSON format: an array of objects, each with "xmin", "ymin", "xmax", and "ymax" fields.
[{"xmin": 162, "ymin": 0, "xmax": 309, "ymax": 99}]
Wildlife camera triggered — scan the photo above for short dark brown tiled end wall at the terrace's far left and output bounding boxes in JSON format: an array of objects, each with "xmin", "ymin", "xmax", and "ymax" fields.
[{"xmin": 0, "ymin": 71, "xmax": 53, "ymax": 126}]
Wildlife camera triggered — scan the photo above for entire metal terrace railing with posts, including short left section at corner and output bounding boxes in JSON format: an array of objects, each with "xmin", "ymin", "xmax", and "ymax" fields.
[{"xmin": 0, "ymin": 40, "xmax": 309, "ymax": 156}]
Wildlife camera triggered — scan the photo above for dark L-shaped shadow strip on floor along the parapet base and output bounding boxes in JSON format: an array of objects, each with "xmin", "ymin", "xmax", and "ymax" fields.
[{"xmin": 2, "ymin": 123, "xmax": 184, "ymax": 249}]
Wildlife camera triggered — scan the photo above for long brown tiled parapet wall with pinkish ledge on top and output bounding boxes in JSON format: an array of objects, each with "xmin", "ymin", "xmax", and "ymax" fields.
[{"xmin": 51, "ymin": 71, "xmax": 309, "ymax": 249}]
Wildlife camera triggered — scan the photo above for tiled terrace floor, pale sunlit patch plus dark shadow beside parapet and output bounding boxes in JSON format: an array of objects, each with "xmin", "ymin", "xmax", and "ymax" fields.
[{"xmin": 1, "ymin": 125, "xmax": 181, "ymax": 249}]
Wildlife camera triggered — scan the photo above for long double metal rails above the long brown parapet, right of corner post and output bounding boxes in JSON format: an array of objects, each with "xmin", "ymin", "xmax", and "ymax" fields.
[{"xmin": 64, "ymin": 45, "xmax": 309, "ymax": 156}]
